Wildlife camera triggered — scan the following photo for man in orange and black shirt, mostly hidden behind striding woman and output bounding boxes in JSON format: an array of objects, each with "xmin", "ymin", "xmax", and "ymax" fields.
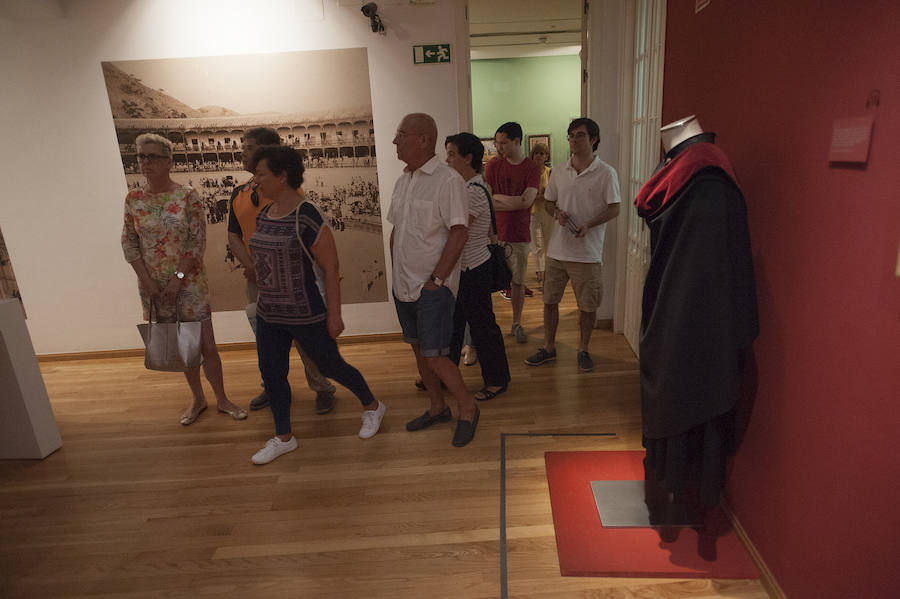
[{"xmin": 228, "ymin": 127, "xmax": 334, "ymax": 414}]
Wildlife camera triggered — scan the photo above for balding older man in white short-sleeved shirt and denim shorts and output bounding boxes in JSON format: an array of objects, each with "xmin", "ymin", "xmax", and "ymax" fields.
[{"xmin": 387, "ymin": 113, "xmax": 479, "ymax": 447}]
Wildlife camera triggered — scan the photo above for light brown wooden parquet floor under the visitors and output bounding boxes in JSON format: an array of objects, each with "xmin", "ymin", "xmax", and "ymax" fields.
[{"xmin": 0, "ymin": 282, "xmax": 767, "ymax": 599}]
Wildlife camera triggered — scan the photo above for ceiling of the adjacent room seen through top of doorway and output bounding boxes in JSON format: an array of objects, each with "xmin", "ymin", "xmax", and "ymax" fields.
[{"xmin": 469, "ymin": 0, "xmax": 584, "ymax": 60}]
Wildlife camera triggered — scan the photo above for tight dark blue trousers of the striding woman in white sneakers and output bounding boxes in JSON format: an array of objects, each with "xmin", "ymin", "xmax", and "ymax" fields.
[{"xmin": 256, "ymin": 316, "xmax": 375, "ymax": 435}]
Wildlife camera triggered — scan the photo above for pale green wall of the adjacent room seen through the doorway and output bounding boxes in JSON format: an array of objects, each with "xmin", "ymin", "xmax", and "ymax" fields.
[{"xmin": 472, "ymin": 55, "xmax": 581, "ymax": 165}]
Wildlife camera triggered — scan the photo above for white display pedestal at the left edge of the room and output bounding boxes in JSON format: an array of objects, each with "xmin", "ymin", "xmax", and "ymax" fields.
[{"xmin": 0, "ymin": 299, "xmax": 62, "ymax": 459}]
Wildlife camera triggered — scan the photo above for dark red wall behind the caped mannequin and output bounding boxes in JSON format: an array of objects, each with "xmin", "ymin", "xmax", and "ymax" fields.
[{"xmin": 663, "ymin": 0, "xmax": 900, "ymax": 599}]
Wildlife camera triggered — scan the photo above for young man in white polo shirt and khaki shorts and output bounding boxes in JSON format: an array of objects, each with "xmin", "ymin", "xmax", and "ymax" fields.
[{"xmin": 525, "ymin": 118, "xmax": 620, "ymax": 372}]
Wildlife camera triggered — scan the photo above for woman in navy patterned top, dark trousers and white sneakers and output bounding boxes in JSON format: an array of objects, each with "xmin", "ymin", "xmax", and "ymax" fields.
[{"xmin": 250, "ymin": 146, "xmax": 385, "ymax": 464}]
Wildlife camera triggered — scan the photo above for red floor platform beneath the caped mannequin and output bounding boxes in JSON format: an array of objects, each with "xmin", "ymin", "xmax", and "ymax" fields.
[{"xmin": 544, "ymin": 451, "xmax": 759, "ymax": 578}]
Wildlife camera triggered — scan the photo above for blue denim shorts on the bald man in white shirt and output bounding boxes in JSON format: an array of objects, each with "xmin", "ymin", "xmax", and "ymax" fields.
[{"xmin": 394, "ymin": 287, "xmax": 456, "ymax": 357}]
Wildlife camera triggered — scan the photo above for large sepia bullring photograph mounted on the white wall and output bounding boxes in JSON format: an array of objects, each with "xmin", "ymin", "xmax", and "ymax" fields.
[{"xmin": 102, "ymin": 48, "xmax": 388, "ymax": 311}]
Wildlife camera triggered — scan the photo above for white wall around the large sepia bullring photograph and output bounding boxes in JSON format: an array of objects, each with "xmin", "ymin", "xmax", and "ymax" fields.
[{"xmin": 0, "ymin": 0, "xmax": 467, "ymax": 354}]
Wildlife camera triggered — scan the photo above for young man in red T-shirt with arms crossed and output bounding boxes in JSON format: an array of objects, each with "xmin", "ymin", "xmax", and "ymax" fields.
[{"xmin": 484, "ymin": 122, "xmax": 541, "ymax": 343}]
